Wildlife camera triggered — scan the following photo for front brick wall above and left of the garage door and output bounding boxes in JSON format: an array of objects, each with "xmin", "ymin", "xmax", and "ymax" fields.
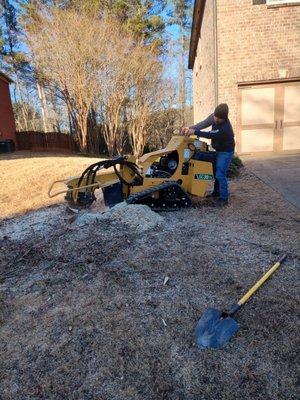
[{"xmin": 216, "ymin": 0, "xmax": 300, "ymax": 133}]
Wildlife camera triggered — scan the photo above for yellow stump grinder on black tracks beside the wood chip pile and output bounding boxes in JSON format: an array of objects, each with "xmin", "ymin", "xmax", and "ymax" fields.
[{"xmin": 49, "ymin": 135, "xmax": 215, "ymax": 211}]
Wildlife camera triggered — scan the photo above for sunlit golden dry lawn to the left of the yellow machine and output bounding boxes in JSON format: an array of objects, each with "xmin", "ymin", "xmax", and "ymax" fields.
[{"xmin": 0, "ymin": 151, "xmax": 105, "ymax": 219}]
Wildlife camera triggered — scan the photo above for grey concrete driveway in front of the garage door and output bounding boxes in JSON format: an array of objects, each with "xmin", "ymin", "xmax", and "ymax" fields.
[{"xmin": 241, "ymin": 154, "xmax": 300, "ymax": 210}]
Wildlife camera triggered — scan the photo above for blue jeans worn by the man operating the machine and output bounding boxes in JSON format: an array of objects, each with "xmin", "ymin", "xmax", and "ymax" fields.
[{"xmin": 214, "ymin": 151, "xmax": 234, "ymax": 200}]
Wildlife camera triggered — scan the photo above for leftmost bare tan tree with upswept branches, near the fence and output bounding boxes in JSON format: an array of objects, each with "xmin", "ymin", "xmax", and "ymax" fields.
[{"xmin": 25, "ymin": 7, "xmax": 108, "ymax": 151}]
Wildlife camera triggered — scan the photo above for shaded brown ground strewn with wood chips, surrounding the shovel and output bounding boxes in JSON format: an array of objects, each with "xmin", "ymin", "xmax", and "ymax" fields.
[{"xmin": 0, "ymin": 165, "xmax": 300, "ymax": 400}]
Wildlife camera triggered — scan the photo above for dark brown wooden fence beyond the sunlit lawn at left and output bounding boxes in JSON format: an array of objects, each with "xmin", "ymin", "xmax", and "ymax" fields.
[{"xmin": 16, "ymin": 131, "xmax": 78, "ymax": 153}]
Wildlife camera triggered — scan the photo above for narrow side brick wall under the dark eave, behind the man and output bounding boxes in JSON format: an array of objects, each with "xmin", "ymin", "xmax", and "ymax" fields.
[{"xmin": 193, "ymin": 0, "xmax": 215, "ymax": 123}]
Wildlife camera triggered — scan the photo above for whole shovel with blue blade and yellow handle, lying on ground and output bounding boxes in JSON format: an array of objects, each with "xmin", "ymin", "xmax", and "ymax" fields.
[{"xmin": 196, "ymin": 255, "xmax": 287, "ymax": 349}]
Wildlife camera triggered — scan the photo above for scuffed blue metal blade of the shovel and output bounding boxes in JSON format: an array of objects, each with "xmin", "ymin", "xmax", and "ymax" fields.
[{"xmin": 195, "ymin": 308, "xmax": 239, "ymax": 349}]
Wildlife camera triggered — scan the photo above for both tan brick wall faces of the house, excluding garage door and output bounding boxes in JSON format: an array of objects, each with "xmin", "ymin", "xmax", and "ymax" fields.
[{"xmin": 193, "ymin": 0, "xmax": 300, "ymax": 134}]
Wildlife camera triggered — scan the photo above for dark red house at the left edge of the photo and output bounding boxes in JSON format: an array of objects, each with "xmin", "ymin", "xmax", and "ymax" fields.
[{"xmin": 0, "ymin": 72, "xmax": 16, "ymax": 144}]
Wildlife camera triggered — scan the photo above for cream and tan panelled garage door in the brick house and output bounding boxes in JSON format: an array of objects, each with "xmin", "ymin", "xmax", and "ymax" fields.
[{"xmin": 238, "ymin": 82, "xmax": 300, "ymax": 153}]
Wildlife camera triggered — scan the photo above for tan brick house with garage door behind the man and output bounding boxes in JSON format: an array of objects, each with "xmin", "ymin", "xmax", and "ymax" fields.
[{"xmin": 189, "ymin": 0, "xmax": 300, "ymax": 153}]
